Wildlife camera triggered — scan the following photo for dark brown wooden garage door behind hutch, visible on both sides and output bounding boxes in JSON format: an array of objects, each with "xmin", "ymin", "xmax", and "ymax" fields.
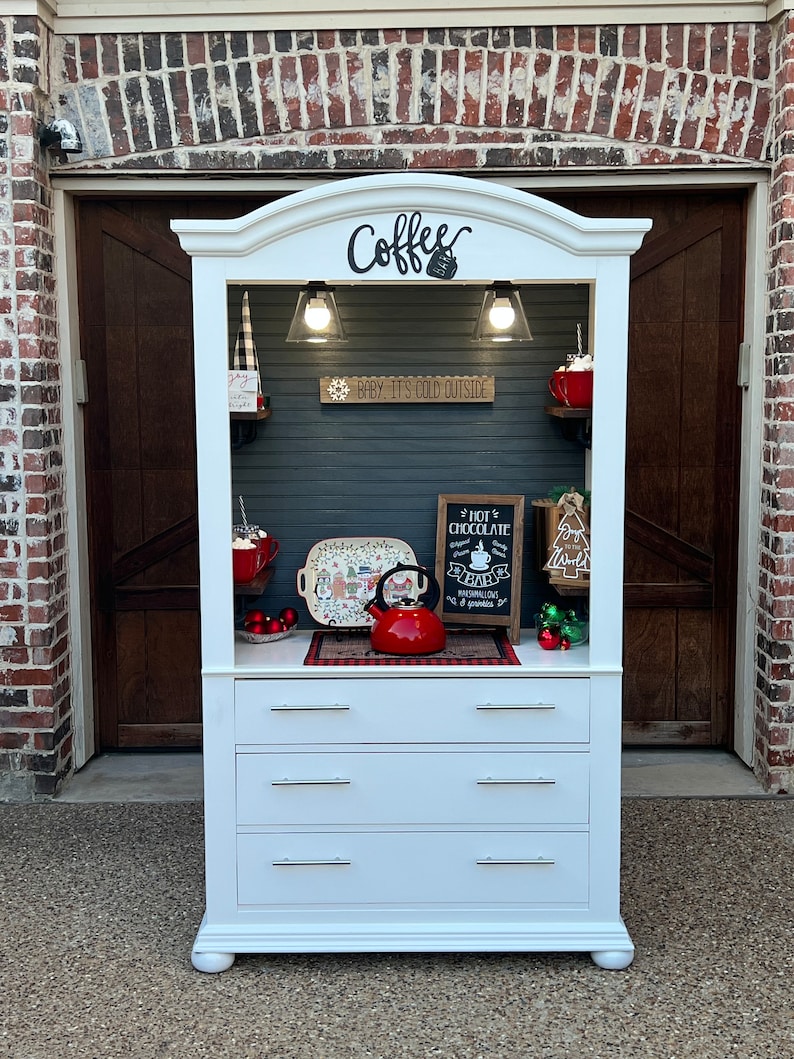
[{"xmin": 78, "ymin": 192, "xmax": 744, "ymax": 748}]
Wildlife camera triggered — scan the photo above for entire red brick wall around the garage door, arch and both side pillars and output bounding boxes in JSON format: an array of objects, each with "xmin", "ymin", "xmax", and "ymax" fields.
[{"xmin": 0, "ymin": 19, "xmax": 794, "ymax": 796}]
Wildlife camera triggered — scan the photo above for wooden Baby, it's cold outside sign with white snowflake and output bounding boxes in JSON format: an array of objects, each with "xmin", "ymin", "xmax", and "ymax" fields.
[{"xmin": 320, "ymin": 375, "xmax": 494, "ymax": 405}]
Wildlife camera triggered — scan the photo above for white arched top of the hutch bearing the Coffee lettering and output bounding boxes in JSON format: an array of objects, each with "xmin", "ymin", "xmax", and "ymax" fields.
[{"xmin": 172, "ymin": 173, "xmax": 650, "ymax": 283}]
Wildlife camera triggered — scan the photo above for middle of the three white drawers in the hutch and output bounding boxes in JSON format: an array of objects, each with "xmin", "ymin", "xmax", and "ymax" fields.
[{"xmin": 237, "ymin": 751, "xmax": 589, "ymax": 827}]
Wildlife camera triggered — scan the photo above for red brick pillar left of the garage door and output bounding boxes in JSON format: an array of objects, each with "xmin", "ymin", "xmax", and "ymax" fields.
[{"xmin": 0, "ymin": 18, "xmax": 72, "ymax": 798}]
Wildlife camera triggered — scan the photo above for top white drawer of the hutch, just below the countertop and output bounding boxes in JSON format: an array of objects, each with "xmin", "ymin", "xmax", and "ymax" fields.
[{"xmin": 235, "ymin": 677, "xmax": 590, "ymax": 744}]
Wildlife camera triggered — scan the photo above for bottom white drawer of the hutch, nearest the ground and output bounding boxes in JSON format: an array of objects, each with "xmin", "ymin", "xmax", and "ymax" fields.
[{"xmin": 237, "ymin": 831, "xmax": 589, "ymax": 908}]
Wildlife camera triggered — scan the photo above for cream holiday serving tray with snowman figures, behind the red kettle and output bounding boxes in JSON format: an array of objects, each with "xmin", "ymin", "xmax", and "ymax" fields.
[{"xmin": 297, "ymin": 537, "xmax": 425, "ymax": 628}]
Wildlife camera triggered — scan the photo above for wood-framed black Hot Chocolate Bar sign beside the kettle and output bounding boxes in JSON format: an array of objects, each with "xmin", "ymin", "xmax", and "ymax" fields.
[{"xmin": 435, "ymin": 493, "xmax": 524, "ymax": 644}]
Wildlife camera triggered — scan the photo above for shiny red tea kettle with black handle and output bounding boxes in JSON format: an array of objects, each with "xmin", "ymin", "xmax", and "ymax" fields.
[{"xmin": 364, "ymin": 562, "xmax": 447, "ymax": 654}]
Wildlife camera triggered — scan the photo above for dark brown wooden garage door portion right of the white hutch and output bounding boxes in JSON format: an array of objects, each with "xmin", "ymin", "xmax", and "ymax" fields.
[{"xmin": 555, "ymin": 192, "xmax": 744, "ymax": 744}]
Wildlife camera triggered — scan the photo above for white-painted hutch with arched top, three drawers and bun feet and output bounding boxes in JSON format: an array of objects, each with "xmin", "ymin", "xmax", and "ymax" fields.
[{"xmin": 173, "ymin": 174, "xmax": 650, "ymax": 971}]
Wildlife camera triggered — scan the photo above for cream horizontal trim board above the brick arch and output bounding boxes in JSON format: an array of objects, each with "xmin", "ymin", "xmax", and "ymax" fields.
[{"xmin": 7, "ymin": 0, "xmax": 794, "ymax": 34}]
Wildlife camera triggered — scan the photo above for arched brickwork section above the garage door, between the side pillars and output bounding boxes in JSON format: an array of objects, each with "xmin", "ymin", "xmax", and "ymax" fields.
[{"xmin": 46, "ymin": 24, "xmax": 772, "ymax": 172}]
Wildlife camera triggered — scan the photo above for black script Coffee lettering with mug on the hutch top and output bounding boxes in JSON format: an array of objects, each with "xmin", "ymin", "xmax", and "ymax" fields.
[{"xmin": 347, "ymin": 210, "xmax": 472, "ymax": 280}]
